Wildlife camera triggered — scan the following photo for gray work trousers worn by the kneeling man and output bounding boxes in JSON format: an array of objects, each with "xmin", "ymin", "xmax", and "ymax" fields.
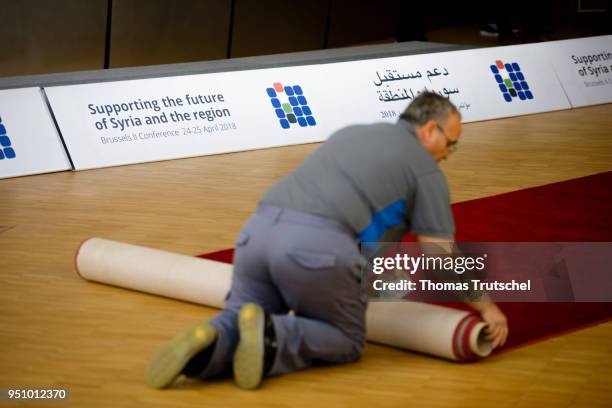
[{"xmin": 198, "ymin": 204, "xmax": 366, "ymax": 379}]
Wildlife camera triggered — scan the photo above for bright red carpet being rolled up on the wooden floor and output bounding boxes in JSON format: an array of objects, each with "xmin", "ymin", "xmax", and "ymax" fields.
[{"xmin": 200, "ymin": 172, "xmax": 612, "ymax": 351}]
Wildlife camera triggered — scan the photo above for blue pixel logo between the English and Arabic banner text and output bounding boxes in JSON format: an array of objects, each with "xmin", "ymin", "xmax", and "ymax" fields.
[{"xmin": 266, "ymin": 82, "xmax": 317, "ymax": 129}]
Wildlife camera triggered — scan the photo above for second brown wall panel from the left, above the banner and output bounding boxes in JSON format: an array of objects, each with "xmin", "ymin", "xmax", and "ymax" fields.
[{"xmin": 110, "ymin": 0, "xmax": 231, "ymax": 68}]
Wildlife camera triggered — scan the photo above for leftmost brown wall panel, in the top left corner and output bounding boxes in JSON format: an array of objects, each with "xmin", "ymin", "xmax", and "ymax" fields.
[{"xmin": 0, "ymin": 0, "xmax": 107, "ymax": 76}]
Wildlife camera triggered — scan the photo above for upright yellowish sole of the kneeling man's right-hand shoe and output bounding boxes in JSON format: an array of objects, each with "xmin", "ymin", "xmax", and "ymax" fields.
[{"xmin": 234, "ymin": 303, "xmax": 265, "ymax": 390}]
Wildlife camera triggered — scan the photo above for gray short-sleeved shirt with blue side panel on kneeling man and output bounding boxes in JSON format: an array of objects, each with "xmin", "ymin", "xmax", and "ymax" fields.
[{"xmin": 261, "ymin": 120, "xmax": 455, "ymax": 242}]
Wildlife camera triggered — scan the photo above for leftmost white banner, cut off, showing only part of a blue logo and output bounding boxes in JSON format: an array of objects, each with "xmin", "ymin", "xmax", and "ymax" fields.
[{"xmin": 0, "ymin": 88, "xmax": 72, "ymax": 178}]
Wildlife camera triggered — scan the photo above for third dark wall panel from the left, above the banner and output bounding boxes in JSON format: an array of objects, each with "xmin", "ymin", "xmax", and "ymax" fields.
[{"xmin": 231, "ymin": 0, "xmax": 329, "ymax": 57}]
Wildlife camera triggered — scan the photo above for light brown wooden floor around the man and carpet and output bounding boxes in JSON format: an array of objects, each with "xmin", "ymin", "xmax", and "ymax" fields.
[{"xmin": 0, "ymin": 105, "xmax": 612, "ymax": 408}]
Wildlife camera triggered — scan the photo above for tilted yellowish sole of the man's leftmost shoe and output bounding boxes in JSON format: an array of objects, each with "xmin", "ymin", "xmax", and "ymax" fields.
[{"xmin": 146, "ymin": 322, "xmax": 217, "ymax": 388}]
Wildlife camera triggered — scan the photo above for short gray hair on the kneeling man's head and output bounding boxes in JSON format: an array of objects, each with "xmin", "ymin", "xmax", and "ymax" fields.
[{"xmin": 400, "ymin": 91, "xmax": 461, "ymax": 126}]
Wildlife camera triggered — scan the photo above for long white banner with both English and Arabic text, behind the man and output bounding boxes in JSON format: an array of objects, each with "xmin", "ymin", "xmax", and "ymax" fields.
[{"xmin": 46, "ymin": 40, "xmax": 570, "ymax": 170}]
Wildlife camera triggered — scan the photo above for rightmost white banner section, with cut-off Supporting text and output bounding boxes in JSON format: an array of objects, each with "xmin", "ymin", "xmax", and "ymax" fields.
[{"xmin": 540, "ymin": 35, "xmax": 612, "ymax": 107}]
